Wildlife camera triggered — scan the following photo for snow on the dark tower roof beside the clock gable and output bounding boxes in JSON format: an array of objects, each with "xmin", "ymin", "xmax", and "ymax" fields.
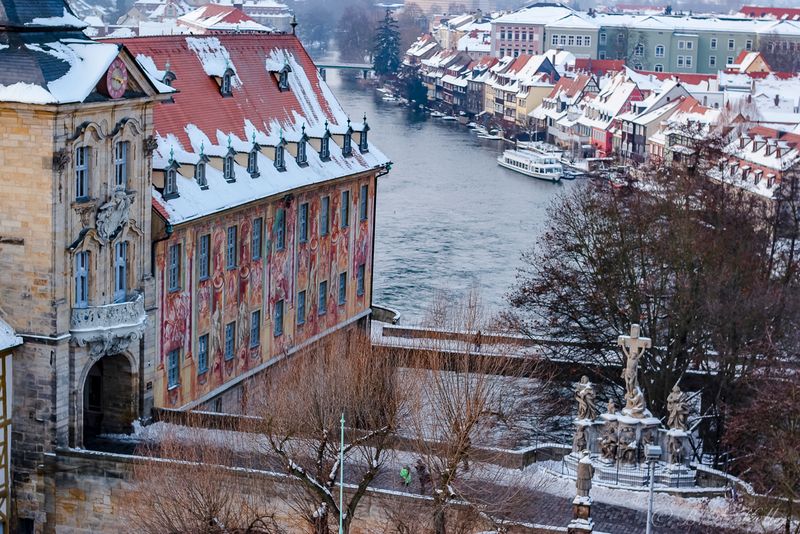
[{"xmin": 0, "ymin": 39, "xmax": 119, "ymax": 104}]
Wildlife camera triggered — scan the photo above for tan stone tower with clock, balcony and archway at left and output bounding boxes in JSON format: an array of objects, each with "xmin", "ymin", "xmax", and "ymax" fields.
[{"xmin": 0, "ymin": 0, "xmax": 169, "ymax": 532}]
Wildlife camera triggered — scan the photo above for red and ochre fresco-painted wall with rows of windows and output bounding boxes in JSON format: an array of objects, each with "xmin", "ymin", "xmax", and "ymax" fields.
[{"xmin": 153, "ymin": 174, "xmax": 376, "ymax": 408}]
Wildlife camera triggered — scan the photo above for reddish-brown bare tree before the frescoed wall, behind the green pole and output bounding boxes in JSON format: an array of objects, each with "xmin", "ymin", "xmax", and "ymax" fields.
[{"xmin": 253, "ymin": 330, "xmax": 402, "ymax": 534}]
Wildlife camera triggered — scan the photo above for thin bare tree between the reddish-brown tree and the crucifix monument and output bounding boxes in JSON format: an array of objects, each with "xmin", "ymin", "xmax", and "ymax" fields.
[{"xmin": 402, "ymin": 292, "xmax": 549, "ymax": 534}]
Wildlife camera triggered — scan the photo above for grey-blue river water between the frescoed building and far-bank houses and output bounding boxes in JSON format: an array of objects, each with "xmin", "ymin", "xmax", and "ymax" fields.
[{"xmin": 318, "ymin": 70, "xmax": 574, "ymax": 324}]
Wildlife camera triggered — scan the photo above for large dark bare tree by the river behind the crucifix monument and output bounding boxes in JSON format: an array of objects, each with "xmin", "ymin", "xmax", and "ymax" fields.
[{"xmin": 507, "ymin": 132, "xmax": 797, "ymax": 460}]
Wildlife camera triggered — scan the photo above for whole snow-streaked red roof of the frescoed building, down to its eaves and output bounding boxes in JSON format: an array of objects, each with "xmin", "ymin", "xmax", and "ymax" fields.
[{"xmin": 119, "ymin": 34, "xmax": 388, "ymax": 224}]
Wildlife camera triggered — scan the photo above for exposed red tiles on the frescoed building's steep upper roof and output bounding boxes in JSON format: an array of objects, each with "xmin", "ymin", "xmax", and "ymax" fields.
[{"xmin": 118, "ymin": 34, "xmax": 336, "ymax": 151}]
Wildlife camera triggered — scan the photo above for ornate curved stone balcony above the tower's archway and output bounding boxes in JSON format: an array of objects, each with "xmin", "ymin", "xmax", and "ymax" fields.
[{"xmin": 70, "ymin": 293, "xmax": 147, "ymax": 356}]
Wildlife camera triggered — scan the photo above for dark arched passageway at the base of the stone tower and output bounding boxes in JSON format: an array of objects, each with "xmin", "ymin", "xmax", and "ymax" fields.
[{"xmin": 83, "ymin": 354, "xmax": 135, "ymax": 447}]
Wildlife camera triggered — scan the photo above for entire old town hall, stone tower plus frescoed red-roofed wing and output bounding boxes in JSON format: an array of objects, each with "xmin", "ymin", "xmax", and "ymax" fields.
[{"xmin": 0, "ymin": 0, "xmax": 389, "ymax": 532}]
